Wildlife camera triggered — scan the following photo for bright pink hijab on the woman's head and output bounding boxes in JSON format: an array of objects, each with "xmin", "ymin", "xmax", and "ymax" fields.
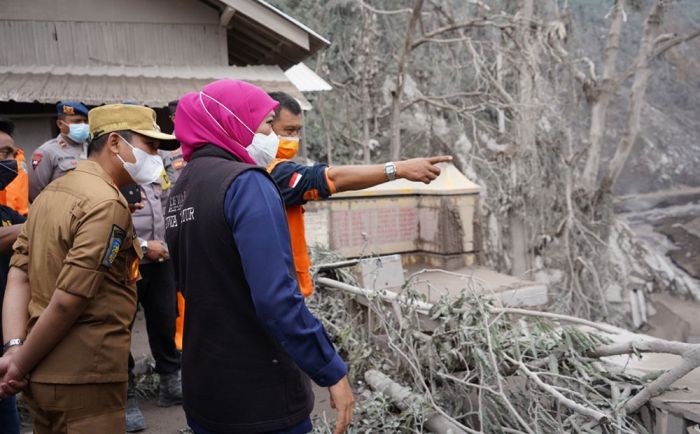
[{"xmin": 175, "ymin": 80, "xmax": 279, "ymax": 164}]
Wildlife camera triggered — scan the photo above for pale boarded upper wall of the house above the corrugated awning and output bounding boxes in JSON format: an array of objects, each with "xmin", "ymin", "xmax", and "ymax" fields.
[{"xmin": 0, "ymin": 20, "xmax": 228, "ymax": 67}]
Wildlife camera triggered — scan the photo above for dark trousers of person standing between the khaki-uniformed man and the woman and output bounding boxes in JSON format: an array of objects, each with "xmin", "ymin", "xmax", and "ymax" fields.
[{"xmin": 129, "ymin": 261, "xmax": 180, "ymax": 378}]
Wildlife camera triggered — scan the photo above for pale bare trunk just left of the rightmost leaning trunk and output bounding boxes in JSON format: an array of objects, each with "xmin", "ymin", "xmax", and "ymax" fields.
[{"xmin": 581, "ymin": 0, "xmax": 625, "ymax": 192}]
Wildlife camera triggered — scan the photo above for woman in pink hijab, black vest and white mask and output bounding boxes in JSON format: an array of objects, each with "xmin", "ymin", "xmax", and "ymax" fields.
[{"xmin": 165, "ymin": 80, "xmax": 354, "ymax": 434}]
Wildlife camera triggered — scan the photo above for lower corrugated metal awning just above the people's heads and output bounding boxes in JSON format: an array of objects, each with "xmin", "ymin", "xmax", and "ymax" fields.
[{"xmin": 0, "ymin": 65, "xmax": 311, "ymax": 109}]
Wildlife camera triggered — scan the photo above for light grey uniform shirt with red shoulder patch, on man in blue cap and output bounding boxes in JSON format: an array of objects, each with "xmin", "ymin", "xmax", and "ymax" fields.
[{"xmin": 29, "ymin": 134, "xmax": 87, "ymax": 202}]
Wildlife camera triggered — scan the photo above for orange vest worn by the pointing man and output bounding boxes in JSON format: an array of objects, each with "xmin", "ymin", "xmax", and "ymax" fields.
[{"xmin": 267, "ymin": 158, "xmax": 314, "ymax": 297}]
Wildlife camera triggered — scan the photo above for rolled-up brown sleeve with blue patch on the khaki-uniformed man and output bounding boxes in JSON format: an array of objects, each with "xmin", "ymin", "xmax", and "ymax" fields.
[{"xmin": 56, "ymin": 200, "xmax": 131, "ymax": 298}]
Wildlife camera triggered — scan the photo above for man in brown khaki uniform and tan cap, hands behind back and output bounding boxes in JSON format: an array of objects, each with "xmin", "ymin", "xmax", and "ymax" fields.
[{"xmin": 0, "ymin": 104, "xmax": 174, "ymax": 434}]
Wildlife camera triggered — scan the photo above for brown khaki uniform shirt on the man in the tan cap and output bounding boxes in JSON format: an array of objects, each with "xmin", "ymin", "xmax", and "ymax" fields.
[{"xmin": 10, "ymin": 160, "xmax": 140, "ymax": 384}]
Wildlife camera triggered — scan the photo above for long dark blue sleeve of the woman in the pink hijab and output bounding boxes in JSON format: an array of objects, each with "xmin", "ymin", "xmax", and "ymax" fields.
[{"xmin": 224, "ymin": 170, "xmax": 347, "ymax": 387}]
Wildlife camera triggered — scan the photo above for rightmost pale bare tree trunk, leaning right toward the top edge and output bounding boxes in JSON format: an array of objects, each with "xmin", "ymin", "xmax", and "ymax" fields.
[{"xmin": 600, "ymin": 0, "xmax": 666, "ymax": 196}]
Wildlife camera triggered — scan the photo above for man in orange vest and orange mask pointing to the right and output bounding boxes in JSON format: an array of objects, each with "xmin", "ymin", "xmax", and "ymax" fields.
[{"xmin": 267, "ymin": 92, "xmax": 452, "ymax": 297}]
